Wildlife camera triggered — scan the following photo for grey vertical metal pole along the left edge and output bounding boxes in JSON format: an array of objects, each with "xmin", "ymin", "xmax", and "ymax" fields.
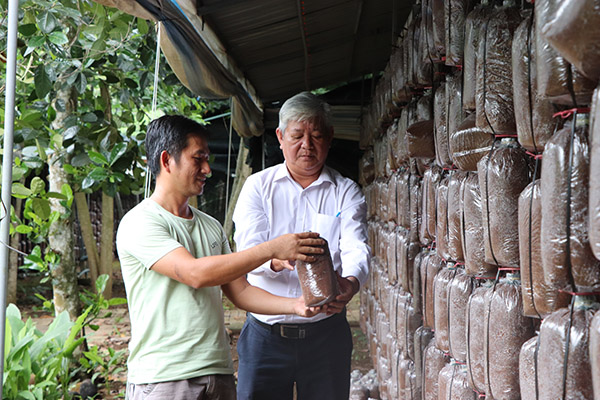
[{"xmin": 0, "ymin": 0, "xmax": 19, "ymax": 398}]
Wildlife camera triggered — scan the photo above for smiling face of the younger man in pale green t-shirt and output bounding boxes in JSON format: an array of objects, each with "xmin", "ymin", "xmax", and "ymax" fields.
[{"xmin": 172, "ymin": 135, "xmax": 211, "ymax": 196}]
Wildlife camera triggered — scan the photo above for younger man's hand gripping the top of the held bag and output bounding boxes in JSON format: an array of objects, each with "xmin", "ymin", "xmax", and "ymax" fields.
[{"xmin": 267, "ymin": 232, "xmax": 325, "ymax": 262}]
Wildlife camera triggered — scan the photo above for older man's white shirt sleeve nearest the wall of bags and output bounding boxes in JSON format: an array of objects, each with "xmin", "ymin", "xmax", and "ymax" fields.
[{"xmin": 339, "ymin": 182, "xmax": 371, "ymax": 286}]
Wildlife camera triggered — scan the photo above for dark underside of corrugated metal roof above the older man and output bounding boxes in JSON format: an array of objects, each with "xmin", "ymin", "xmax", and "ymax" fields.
[{"xmin": 197, "ymin": 0, "xmax": 414, "ymax": 103}]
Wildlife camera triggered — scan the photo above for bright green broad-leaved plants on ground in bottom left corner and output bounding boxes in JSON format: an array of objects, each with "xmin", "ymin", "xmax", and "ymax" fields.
[{"xmin": 3, "ymin": 275, "xmax": 125, "ymax": 400}]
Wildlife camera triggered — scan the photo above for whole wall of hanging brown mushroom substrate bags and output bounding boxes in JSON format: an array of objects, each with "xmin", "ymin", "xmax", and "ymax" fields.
[{"xmin": 359, "ymin": 0, "xmax": 600, "ymax": 400}]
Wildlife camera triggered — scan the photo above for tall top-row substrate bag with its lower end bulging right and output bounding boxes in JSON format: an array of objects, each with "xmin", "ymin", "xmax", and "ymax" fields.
[{"xmin": 512, "ymin": 15, "xmax": 561, "ymax": 153}]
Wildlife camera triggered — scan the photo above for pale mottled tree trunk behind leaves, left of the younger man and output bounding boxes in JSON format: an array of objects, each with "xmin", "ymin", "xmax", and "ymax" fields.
[{"xmin": 48, "ymin": 88, "xmax": 81, "ymax": 320}]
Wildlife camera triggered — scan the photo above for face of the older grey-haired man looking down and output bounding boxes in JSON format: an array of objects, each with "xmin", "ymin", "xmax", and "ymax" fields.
[{"xmin": 277, "ymin": 121, "xmax": 333, "ymax": 180}]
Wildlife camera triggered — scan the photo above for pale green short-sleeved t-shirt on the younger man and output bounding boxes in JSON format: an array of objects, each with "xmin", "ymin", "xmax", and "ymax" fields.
[{"xmin": 117, "ymin": 199, "xmax": 233, "ymax": 384}]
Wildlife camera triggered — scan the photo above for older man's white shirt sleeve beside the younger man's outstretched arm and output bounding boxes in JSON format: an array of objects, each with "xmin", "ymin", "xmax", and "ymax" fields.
[{"xmin": 232, "ymin": 176, "xmax": 279, "ymax": 277}]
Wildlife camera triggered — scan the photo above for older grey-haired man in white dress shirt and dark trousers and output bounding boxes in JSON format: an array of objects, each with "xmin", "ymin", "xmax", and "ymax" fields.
[{"xmin": 233, "ymin": 92, "xmax": 370, "ymax": 400}]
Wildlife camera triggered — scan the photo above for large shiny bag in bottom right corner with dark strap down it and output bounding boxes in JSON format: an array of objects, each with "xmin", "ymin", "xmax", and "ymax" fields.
[{"xmin": 538, "ymin": 308, "xmax": 594, "ymax": 399}]
